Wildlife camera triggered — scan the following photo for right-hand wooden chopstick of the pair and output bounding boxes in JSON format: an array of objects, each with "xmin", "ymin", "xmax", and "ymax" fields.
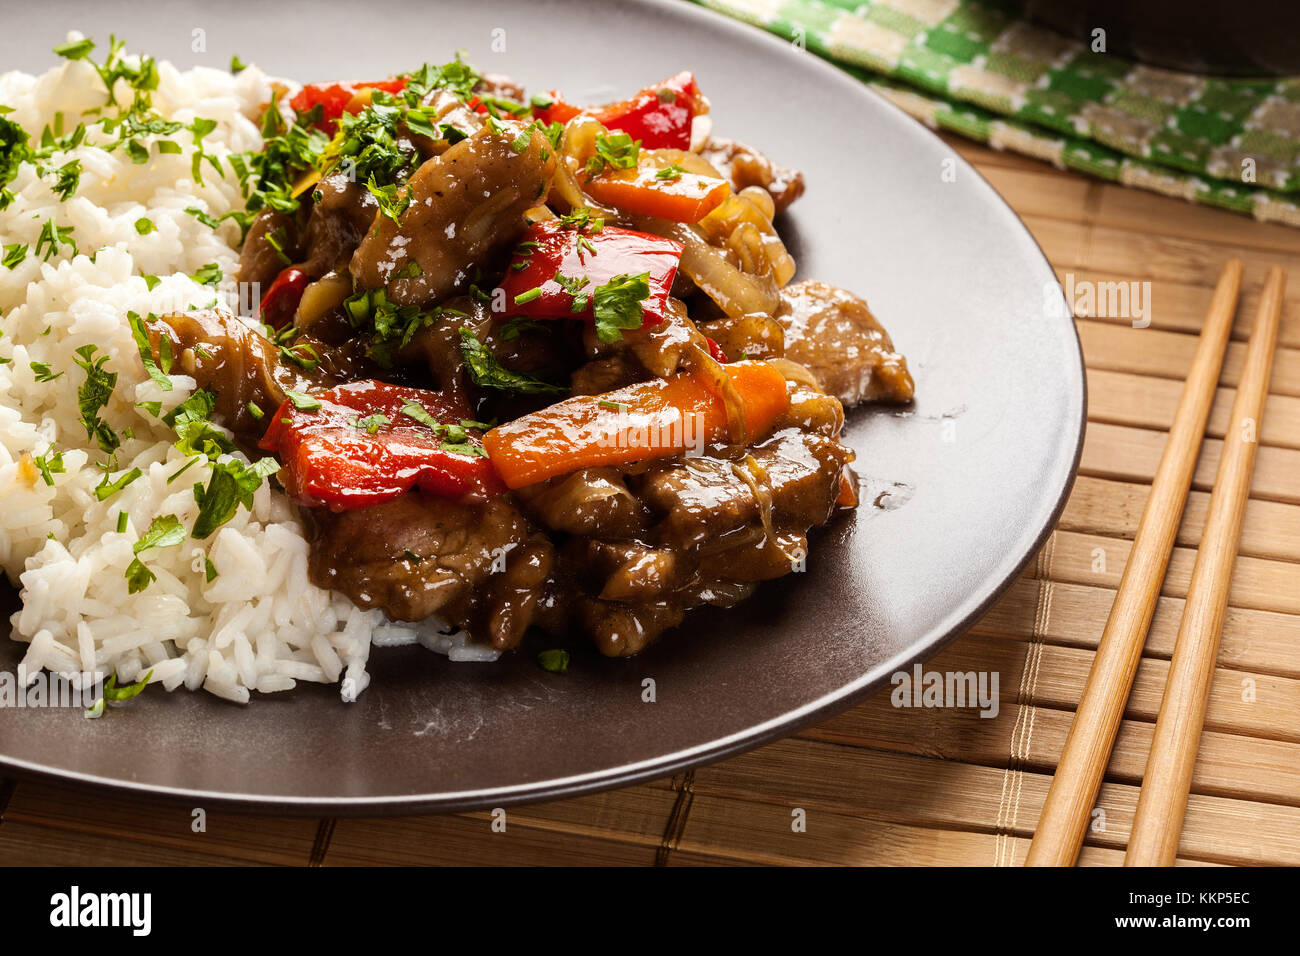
[{"xmin": 1125, "ymin": 268, "xmax": 1287, "ymax": 866}]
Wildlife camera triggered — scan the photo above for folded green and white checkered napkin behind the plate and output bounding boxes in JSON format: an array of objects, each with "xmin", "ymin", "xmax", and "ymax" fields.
[{"xmin": 696, "ymin": 0, "xmax": 1300, "ymax": 226}]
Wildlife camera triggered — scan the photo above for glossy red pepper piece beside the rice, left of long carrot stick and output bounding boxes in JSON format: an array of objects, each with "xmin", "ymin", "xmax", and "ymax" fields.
[{"xmin": 260, "ymin": 381, "xmax": 504, "ymax": 511}]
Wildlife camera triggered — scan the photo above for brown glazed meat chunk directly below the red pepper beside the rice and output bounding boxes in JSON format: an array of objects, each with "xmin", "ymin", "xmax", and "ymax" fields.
[{"xmin": 309, "ymin": 492, "xmax": 551, "ymax": 648}]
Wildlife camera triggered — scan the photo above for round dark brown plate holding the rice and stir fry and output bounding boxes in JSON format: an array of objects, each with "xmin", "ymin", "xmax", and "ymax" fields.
[{"xmin": 0, "ymin": 0, "xmax": 1084, "ymax": 813}]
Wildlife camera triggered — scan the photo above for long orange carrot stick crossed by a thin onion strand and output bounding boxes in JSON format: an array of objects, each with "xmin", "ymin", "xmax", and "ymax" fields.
[{"xmin": 484, "ymin": 362, "xmax": 790, "ymax": 488}]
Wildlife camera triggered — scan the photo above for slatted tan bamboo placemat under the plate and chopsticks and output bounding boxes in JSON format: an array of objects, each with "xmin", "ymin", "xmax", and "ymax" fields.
[{"xmin": 0, "ymin": 138, "xmax": 1300, "ymax": 865}]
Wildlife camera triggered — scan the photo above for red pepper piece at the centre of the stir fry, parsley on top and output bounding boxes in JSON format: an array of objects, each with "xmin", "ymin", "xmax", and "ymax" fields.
[{"xmin": 501, "ymin": 219, "xmax": 681, "ymax": 325}]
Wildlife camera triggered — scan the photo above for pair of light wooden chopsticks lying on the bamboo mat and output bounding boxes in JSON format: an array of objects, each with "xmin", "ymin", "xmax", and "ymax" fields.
[{"xmin": 1026, "ymin": 259, "xmax": 1286, "ymax": 866}]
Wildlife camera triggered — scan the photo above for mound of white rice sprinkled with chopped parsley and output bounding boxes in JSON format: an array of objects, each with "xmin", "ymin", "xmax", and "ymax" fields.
[{"xmin": 0, "ymin": 34, "xmax": 495, "ymax": 704}]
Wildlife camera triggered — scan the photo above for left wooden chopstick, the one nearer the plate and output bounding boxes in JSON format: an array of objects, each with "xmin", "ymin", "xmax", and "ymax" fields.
[{"xmin": 1024, "ymin": 259, "xmax": 1243, "ymax": 866}]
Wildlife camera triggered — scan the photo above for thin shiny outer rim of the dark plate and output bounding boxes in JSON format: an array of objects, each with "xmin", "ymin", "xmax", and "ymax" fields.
[{"xmin": 0, "ymin": 0, "xmax": 1088, "ymax": 817}]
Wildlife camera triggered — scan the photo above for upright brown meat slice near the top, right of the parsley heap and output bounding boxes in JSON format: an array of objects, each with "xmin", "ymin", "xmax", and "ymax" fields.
[{"xmin": 351, "ymin": 121, "xmax": 555, "ymax": 307}]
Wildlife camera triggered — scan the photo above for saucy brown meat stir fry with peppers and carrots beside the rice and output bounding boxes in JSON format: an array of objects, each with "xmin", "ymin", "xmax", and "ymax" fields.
[{"xmin": 147, "ymin": 61, "xmax": 913, "ymax": 656}]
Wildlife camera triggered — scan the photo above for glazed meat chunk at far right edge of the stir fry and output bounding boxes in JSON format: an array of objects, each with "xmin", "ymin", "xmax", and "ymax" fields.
[{"xmin": 775, "ymin": 280, "xmax": 914, "ymax": 405}]
